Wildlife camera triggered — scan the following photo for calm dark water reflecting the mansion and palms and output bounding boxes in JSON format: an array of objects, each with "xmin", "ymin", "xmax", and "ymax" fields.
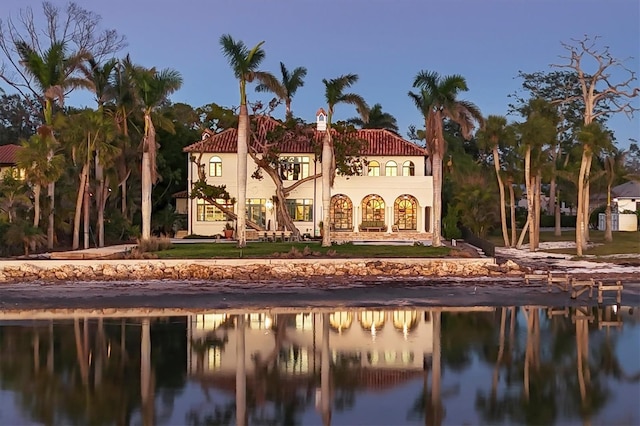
[{"xmin": 0, "ymin": 307, "xmax": 640, "ymax": 425}]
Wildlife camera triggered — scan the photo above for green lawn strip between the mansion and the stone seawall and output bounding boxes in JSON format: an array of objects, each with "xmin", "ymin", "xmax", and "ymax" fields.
[{"xmin": 155, "ymin": 241, "xmax": 451, "ymax": 259}]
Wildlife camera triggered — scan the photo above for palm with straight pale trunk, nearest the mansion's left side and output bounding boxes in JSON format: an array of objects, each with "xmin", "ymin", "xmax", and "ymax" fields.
[{"xmin": 129, "ymin": 67, "xmax": 182, "ymax": 240}]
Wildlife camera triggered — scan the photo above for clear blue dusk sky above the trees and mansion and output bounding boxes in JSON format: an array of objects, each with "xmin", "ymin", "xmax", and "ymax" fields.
[{"xmin": 0, "ymin": 0, "xmax": 640, "ymax": 147}]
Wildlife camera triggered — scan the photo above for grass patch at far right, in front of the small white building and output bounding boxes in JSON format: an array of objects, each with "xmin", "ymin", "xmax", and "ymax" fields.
[{"xmin": 488, "ymin": 231, "xmax": 640, "ymax": 257}]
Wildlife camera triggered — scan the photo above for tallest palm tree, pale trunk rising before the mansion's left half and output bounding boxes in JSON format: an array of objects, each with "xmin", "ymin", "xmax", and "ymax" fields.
[{"xmin": 220, "ymin": 34, "xmax": 279, "ymax": 248}]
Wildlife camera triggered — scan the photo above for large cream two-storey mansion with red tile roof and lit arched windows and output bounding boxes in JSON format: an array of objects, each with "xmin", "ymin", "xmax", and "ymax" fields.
[{"xmin": 183, "ymin": 110, "xmax": 433, "ymax": 241}]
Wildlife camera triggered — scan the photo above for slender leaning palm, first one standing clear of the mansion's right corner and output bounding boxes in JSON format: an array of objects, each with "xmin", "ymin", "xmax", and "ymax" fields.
[{"xmin": 476, "ymin": 115, "xmax": 511, "ymax": 247}]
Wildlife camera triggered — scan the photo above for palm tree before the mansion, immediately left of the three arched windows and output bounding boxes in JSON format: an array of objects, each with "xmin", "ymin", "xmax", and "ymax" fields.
[{"xmin": 322, "ymin": 74, "xmax": 369, "ymax": 247}]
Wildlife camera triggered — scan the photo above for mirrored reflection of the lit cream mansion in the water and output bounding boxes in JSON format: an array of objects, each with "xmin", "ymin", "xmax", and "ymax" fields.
[{"xmin": 188, "ymin": 310, "xmax": 433, "ymax": 388}]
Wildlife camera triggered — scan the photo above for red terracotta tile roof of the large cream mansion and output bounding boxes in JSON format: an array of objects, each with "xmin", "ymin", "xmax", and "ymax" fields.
[{"xmin": 183, "ymin": 118, "xmax": 427, "ymax": 156}]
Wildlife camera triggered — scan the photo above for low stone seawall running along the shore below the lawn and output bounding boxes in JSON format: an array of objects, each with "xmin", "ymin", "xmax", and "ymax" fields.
[{"xmin": 0, "ymin": 258, "xmax": 523, "ymax": 283}]
